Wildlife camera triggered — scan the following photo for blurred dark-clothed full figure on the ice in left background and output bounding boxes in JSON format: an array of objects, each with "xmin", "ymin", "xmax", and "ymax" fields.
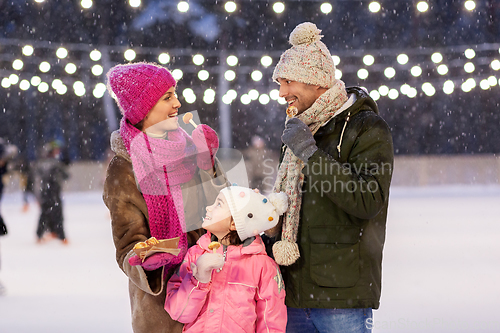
[{"xmin": 35, "ymin": 140, "xmax": 68, "ymax": 245}]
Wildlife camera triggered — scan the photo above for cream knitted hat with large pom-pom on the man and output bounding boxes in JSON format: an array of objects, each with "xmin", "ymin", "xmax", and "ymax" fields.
[{"xmin": 273, "ymin": 22, "xmax": 337, "ymax": 89}]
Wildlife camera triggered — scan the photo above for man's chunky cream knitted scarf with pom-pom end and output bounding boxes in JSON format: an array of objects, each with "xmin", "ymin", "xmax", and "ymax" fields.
[{"xmin": 273, "ymin": 80, "xmax": 347, "ymax": 266}]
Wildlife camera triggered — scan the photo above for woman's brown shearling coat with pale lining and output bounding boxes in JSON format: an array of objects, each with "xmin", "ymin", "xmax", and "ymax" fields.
[{"xmin": 103, "ymin": 131, "xmax": 228, "ymax": 333}]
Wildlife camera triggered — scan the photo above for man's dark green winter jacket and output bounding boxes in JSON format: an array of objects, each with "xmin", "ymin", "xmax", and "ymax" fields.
[{"xmin": 282, "ymin": 87, "xmax": 394, "ymax": 309}]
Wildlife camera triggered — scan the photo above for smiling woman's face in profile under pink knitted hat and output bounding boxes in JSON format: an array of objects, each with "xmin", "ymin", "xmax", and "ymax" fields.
[{"xmin": 142, "ymin": 87, "xmax": 181, "ymax": 135}]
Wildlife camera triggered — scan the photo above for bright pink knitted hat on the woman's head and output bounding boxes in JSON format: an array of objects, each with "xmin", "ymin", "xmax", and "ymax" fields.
[{"xmin": 107, "ymin": 62, "xmax": 176, "ymax": 125}]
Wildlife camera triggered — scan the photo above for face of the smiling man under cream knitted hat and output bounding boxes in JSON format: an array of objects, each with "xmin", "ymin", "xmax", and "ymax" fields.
[{"xmin": 278, "ymin": 78, "xmax": 321, "ymax": 114}]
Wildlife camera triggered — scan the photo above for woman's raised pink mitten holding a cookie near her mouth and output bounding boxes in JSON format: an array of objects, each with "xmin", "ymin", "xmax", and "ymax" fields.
[{"xmin": 192, "ymin": 124, "xmax": 219, "ymax": 170}]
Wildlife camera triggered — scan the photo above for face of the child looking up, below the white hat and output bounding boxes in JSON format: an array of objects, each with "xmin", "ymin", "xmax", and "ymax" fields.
[{"xmin": 201, "ymin": 193, "xmax": 234, "ymax": 239}]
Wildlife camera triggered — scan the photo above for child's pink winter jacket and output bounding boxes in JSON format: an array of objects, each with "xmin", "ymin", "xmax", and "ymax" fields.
[{"xmin": 165, "ymin": 233, "xmax": 287, "ymax": 333}]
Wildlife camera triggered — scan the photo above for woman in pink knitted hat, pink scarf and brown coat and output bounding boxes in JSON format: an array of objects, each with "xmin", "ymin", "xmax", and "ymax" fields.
[{"xmin": 103, "ymin": 62, "xmax": 227, "ymax": 333}]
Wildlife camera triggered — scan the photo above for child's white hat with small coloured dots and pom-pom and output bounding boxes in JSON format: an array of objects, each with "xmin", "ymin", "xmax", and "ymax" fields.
[{"xmin": 221, "ymin": 186, "xmax": 288, "ymax": 241}]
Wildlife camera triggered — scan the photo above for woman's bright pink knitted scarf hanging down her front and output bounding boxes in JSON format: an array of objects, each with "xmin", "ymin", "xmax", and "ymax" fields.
[{"xmin": 120, "ymin": 117, "xmax": 196, "ymax": 269}]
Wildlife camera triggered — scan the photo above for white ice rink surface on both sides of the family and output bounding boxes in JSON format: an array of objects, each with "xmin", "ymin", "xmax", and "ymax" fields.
[{"xmin": 0, "ymin": 186, "xmax": 500, "ymax": 333}]
